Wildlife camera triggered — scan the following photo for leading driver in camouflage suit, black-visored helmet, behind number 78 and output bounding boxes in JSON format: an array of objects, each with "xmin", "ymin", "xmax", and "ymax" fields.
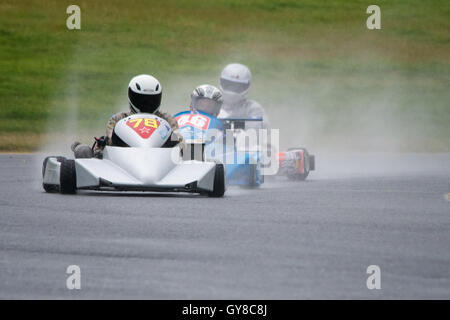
[{"xmin": 71, "ymin": 74, "xmax": 183, "ymax": 158}]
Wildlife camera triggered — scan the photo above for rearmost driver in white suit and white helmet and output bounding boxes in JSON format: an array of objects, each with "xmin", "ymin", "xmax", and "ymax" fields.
[{"xmin": 218, "ymin": 63, "xmax": 270, "ymax": 129}]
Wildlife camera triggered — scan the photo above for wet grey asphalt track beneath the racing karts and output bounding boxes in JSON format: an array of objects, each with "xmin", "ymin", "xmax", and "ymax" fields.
[{"xmin": 0, "ymin": 154, "xmax": 450, "ymax": 299}]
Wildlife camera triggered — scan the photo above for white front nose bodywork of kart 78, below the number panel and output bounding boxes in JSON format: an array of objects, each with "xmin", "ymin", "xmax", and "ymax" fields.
[{"xmin": 75, "ymin": 147, "xmax": 216, "ymax": 191}]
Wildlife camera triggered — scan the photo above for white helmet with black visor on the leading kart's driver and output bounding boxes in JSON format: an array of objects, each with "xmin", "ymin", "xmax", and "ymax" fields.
[{"xmin": 128, "ymin": 74, "xmax": 162, "ymax": 113}]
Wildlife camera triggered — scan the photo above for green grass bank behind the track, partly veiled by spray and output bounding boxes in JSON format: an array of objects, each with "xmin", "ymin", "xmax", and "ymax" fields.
[{"xmin": 0, "ymin": 0, "xmax": 450, "ymax": 152}]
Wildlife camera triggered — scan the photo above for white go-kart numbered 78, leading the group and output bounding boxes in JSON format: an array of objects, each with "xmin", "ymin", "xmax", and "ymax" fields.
[{"xmin": 42, "ymin": 113, "xmax": 225, "ymax": 197}]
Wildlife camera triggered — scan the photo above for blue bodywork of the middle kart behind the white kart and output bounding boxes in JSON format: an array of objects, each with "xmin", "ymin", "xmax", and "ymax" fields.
[{"xmin": 175, "ymin": 110, "xmax": 264, "ymax": 187}]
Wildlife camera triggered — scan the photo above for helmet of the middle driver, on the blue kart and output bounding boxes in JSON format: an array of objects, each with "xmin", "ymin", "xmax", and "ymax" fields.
[{"xmin": 191, "ymin": 84, "xmax": 223, "ymax": 117}]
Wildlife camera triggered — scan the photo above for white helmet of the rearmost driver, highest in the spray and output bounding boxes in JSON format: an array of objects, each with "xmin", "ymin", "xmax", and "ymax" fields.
[{"xmin": 220, "ymin": 63, "xmax": 252, "ymax": 104}]
